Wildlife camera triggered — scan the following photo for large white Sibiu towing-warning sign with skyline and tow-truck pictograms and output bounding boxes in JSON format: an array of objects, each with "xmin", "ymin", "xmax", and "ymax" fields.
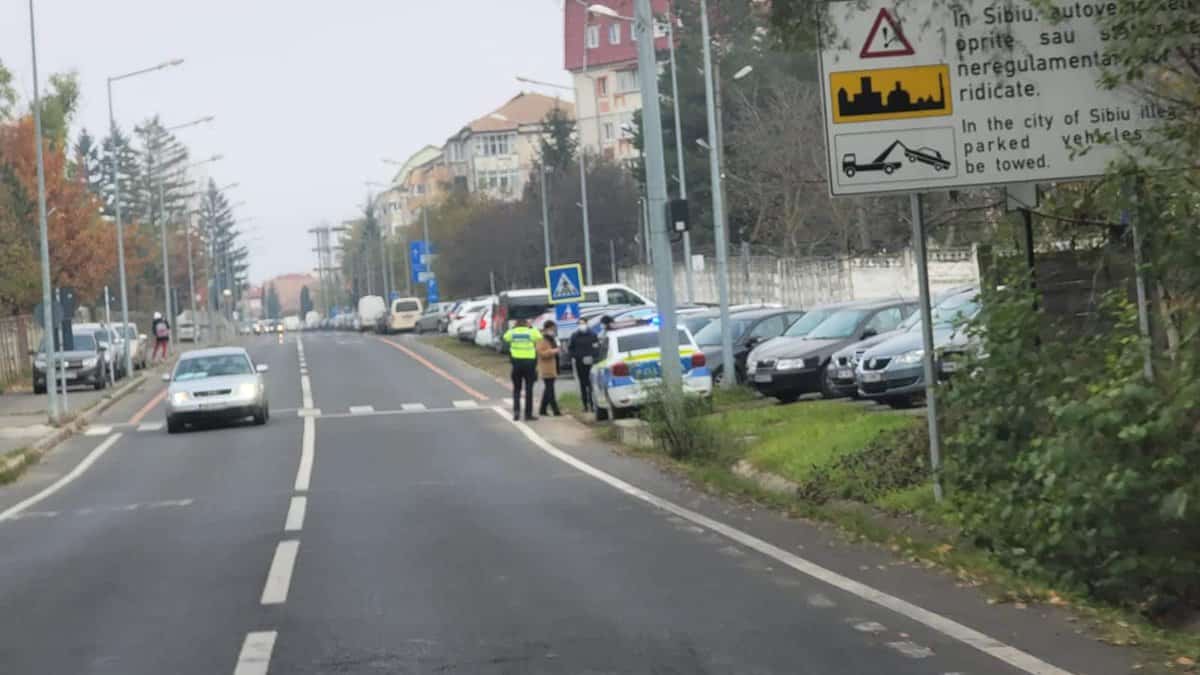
[{"xmin": 821, "ymin": 0, "xmax": 1180, "ymax": 195}]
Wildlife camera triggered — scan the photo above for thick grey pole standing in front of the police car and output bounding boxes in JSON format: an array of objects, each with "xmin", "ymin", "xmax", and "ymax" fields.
[{"xmin": 634, "ymin": 0, "xmax": 681, "ymax": 389}]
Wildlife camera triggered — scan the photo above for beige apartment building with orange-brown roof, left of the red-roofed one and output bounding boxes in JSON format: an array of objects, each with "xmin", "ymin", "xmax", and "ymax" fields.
[{"xmin": 443, "ymin": 92, "xmax": 575, "ymax": 201}]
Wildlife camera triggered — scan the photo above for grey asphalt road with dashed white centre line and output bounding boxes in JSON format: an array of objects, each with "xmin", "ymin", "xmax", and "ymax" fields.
[{"xmin": 0, "ymin": 333, "xmax": 1132, "ymax": 675}]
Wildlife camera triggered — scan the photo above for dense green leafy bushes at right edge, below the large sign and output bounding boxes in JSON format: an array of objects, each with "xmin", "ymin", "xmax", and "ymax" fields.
[{"xmin": 946, "ymin": 273, "xmax": 1200, "ymax": 611}]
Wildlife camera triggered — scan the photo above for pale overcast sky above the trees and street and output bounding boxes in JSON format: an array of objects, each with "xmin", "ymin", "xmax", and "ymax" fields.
[{"xmin": 0, "ymin": 0, "xmax": 570, "ymax": 282}]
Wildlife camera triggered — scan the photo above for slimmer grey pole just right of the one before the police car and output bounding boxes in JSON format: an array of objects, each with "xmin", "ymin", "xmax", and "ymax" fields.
[{"xmin": 700, "ymin": 0, "xmax": 737, "ymax": 388}]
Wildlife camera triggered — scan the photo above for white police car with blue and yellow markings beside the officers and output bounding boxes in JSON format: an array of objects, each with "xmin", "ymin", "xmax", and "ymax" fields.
[{"xmin": 592, "ymin": 325, "xmax": 713, "ymax": 420}]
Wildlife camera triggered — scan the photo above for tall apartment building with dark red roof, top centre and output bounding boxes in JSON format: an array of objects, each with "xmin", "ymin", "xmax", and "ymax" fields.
[{"xmin": 563, "ymin": 0, "xmax": 670, "ymax": 161}]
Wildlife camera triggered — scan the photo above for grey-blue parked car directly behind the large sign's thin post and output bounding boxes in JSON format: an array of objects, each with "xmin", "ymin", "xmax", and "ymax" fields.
[{"xmin": 857, "ymin": 291, "xmax": 979, "ymax": 407}]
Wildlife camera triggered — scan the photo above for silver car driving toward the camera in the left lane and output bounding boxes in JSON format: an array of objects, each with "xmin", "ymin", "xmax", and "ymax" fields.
[{"xmin": 162, "ymin": 347, "xmax": 270, "ymax": 434}]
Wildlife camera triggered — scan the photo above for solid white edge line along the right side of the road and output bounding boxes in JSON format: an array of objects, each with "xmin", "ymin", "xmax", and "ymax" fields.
[{"xmin": 492, "ymin": 407, "xmax": 1072, "ymax": 675}]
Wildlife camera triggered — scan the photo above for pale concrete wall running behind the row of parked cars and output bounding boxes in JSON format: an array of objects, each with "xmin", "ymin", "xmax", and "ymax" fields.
[{"xmin": 619, "ymin": 249, "xmax": 979, "ymax": 307}]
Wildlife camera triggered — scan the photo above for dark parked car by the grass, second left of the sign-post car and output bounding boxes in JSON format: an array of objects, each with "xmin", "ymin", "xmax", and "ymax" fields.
[{"xmin": 746, "ymin": 299, "xmax": 917, "ymax": 402}]
